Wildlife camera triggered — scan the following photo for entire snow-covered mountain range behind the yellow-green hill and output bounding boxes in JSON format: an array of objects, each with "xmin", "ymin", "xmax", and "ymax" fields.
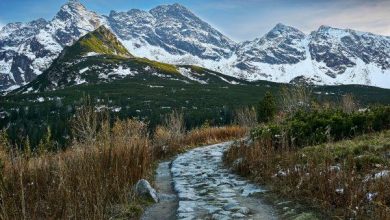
[{"xmin": 0, "ymin": 0, "xmax": 390, "ymax": 90}]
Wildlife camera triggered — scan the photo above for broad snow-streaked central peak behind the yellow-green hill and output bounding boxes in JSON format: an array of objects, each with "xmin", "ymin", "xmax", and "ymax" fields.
[{"xmin": 108, "ymin": 4, "xmax": 236, "ymax": 64}]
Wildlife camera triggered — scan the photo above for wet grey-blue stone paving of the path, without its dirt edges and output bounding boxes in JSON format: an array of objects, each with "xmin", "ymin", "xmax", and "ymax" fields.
[{"xmin": 171, "ymin": 142, "xmax": 278, "ymax": 220}]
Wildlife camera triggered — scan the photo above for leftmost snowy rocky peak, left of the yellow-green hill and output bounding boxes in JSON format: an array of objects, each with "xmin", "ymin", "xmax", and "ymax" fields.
[{"xmin": 0, "ymin": 0, "xmax": 104, "ymax": 90}]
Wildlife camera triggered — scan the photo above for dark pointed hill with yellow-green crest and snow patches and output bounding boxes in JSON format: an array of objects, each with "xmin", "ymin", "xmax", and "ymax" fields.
[{"xmin": 13, "ymin": 25, "xmax": 247, "ymax": 93}]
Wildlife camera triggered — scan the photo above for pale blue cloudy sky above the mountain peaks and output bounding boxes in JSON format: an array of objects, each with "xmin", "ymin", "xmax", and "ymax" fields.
[{"xmin": 0, "ymin": 0, "xmax": 390, "ymax": 41}]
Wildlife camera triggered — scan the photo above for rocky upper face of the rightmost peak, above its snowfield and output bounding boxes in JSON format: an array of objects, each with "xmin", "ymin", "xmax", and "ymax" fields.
[{"xmin": 309, "ymin": 26, "xmax": 390, "ymax": 78}]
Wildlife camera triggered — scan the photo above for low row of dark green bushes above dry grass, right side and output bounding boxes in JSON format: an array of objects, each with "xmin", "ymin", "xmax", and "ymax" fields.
[{"xmin": 251, "ymin": 106, "xmax": 390, "ymax": 148}]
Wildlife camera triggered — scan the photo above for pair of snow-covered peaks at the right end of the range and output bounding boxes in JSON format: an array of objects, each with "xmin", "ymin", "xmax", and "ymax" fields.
[{"xmin": 225, "ymin": 24, "xmax": 390, "ymax": 88}]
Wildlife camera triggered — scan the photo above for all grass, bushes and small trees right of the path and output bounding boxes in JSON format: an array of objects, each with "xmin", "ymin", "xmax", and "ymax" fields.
[{"xmin": 224, "ymin": 88, "xmax": 390, "ymax": 219}]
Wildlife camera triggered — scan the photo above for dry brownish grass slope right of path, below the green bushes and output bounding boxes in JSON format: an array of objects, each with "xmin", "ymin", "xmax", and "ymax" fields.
[{"xmin": 224, "ymin": 131, "xmax": 390, "ymax": 219}]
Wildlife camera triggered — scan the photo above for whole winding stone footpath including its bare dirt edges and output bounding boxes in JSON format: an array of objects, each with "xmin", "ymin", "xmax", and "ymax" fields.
[{"xmin": 142, "ymin": 142, "xmax": 317, "ymax": 220}]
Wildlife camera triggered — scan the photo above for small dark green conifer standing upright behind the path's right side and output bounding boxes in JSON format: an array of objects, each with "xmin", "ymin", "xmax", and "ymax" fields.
[{"xmin": 257, "ymin": 92, "xmax": 276, "ymax": 123}]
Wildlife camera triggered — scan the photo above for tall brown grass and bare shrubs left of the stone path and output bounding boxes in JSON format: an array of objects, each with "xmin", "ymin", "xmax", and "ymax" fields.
[{"xmin": 0, "ymin": 106, "xmax": 245, "ymax": 219}]
